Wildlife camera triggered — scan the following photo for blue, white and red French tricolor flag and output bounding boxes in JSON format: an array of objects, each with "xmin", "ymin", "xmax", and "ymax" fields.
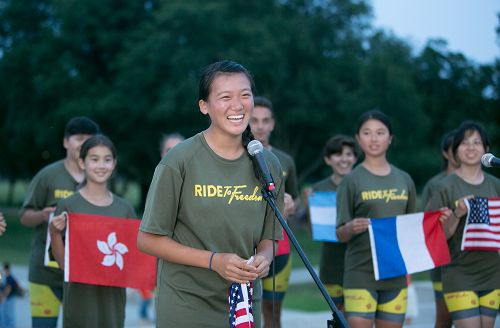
[{"xmin": 369, "ymin": 211, "xmax": 450, "ymax": 280}]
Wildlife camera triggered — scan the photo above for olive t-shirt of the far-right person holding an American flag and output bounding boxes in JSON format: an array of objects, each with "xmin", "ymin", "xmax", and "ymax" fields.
[{"xmin": 429, "ymin": 173, "xmax": 500, "ymax": 293}]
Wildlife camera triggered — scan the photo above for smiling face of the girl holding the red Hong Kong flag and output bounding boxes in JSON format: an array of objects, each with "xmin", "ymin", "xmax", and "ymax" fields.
[{"xmin": 78, "ymin": 145, "xmax": 116, "ymax": 184}]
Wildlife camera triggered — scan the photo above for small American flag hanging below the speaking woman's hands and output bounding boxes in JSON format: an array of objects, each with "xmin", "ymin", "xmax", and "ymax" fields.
[{"xmin": 229, "ymin": 282, "xmax": 254, "ymax": 328}]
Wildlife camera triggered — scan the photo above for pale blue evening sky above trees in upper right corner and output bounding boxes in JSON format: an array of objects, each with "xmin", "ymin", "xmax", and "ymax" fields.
[{"xmin": 371, "ymin": 0, "xmax": 500, "ymax": 64}]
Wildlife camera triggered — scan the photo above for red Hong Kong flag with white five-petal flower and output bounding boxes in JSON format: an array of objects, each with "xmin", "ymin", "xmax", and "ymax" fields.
[{"xmin": 64, "ymin": 213, "xmax": 156, "ymax": 290}]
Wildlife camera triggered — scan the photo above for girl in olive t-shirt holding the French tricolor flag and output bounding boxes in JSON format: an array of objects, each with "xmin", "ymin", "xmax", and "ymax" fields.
[{"xmin": 337, "ymin": 110, "xmax": 416, "ymax": 327}]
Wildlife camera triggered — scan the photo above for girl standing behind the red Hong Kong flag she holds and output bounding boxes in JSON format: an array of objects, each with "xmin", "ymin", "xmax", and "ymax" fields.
[{"xmin": 49, "ymin": 135, "xmax": 137, "ymax": 328}]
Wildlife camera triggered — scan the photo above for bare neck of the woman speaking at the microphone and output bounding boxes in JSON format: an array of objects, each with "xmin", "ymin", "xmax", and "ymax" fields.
[{"xmin": 203, "ymin": 127, "xmax": 245, "ymax": 160}]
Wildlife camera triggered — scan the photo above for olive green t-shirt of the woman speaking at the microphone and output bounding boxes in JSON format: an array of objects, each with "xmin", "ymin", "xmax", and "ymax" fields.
[{"xmin": 140, "ymin": 133, "xmax": 283, "ymax": 328}]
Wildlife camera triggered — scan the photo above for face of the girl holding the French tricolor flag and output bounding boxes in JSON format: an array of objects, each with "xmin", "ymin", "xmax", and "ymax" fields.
[{"xmin": 356, "ymin": 119, "xmax": 392, "ymax": 157}]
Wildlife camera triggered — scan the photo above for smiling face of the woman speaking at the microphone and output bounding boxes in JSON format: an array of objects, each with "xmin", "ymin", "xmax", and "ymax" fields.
[{"xmin": 199, "ymin": 73, "xmax": 253, "ymax": 136}]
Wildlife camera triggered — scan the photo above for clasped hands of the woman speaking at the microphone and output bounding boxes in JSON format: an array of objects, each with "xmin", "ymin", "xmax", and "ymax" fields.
[{"xmin": 212, "ymin": 253, "xmax": 258, "ymax": 284}]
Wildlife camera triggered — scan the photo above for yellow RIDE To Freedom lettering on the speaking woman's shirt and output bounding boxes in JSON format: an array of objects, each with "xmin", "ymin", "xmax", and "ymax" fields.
[{"xmin": 194, "ymin": 184, "xmax": 262, "ymax": 204}]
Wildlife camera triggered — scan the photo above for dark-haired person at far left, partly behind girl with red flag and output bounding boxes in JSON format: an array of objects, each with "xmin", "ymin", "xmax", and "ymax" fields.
[{"xmin": 21, "ymin": 116, "xmax": 100, "ymax": 328}]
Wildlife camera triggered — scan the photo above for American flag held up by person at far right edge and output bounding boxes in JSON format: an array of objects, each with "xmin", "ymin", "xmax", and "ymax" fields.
[{"xmin": 462, "ymin": 197, "xmax": 500, "ymax": 251}]
